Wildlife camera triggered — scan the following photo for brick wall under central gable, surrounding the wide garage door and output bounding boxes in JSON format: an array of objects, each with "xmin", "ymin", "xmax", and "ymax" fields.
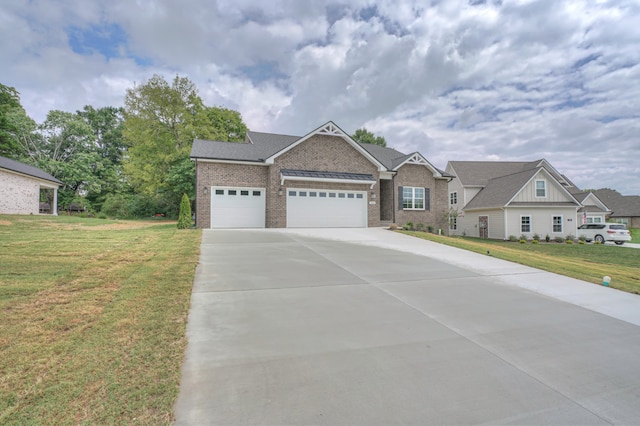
[{"xmin": 266, "ymin": 135, "xmax": 380, "ymax": 228}]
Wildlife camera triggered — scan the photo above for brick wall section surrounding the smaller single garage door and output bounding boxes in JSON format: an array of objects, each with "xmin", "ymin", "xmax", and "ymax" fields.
[{"xmin": 196, "ymin": 161, "xmax": 270, "ymax": 228}]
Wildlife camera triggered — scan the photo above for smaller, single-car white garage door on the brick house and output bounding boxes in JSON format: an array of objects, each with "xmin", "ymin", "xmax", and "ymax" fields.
[{"xmin": 211, "ymin": 186, "xmax": 266, "ymax": 228}]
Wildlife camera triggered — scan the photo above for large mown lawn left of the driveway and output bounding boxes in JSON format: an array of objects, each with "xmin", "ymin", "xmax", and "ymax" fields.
[{"xmin": 0, "ymin": 215, "xmax": 201, "ymax": 424}]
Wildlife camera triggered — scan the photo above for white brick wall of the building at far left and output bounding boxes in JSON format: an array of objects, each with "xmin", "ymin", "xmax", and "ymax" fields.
[{"xmin": 0, "ymin": 170, "xmax": 40, "ymax": 214}]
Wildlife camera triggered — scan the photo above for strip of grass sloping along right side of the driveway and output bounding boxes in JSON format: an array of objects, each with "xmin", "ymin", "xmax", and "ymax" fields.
[{"xmin": 400, "ymin": 231, "xmax": 640, "ymax": 294}]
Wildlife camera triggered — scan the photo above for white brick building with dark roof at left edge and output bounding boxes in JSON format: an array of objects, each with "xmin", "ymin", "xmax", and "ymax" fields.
[{"xmin": 0, "ymin": 157, "xmax": 62, "ymax": 214}]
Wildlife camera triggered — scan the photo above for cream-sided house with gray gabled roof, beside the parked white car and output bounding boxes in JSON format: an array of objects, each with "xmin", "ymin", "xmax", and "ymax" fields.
[{"xmin": 446, "ymin": 159, "xmax": 610, "ymax": 240}]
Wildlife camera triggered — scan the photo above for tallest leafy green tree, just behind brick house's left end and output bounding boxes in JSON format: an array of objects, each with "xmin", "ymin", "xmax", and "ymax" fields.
[{"xmin": 123, "ymin": 75, "xmax": 247, "ymax": 213}]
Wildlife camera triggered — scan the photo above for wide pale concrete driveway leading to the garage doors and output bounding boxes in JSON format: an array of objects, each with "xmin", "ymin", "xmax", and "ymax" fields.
[{"xmin": 175, "ymin": 229, "xmax": 640, "ymax": 425}]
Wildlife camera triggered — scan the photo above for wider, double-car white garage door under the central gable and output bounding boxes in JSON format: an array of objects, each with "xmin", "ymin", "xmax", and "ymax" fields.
[{"xmin": 287, "ymin": 188, "xmax": 367, "ymax": 228}]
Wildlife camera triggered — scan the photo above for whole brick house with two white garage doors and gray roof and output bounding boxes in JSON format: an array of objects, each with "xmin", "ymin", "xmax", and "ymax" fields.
[{"xmin": 191, "ymin": 122, "xmax": 451, "ymax": 228}]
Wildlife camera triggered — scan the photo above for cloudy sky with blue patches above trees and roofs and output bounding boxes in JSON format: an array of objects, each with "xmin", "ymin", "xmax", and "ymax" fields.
[{"xmin": 0, "ymin": 0, "xmax": 640, "ymax": 195}]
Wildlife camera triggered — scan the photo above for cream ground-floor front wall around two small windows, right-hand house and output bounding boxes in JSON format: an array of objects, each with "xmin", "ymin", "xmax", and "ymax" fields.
[{"xmin": 506, "ymin": 207, "xmax": 580, "ymax": 238}]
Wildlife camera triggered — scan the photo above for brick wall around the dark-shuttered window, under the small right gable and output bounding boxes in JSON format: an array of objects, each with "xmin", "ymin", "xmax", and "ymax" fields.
[{"xmin": 394, "ymin": 164, "xmax": 449, "ymax": 232}]
